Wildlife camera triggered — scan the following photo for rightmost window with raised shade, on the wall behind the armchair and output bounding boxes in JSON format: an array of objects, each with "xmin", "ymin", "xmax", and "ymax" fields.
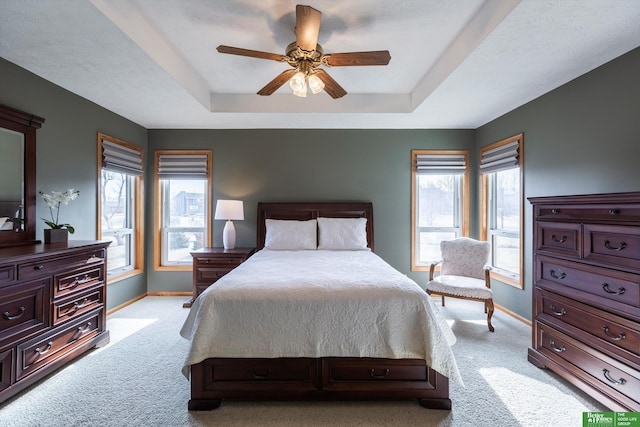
[{"xmin": 480, "ymin": 134, "xmax": 524, "ymax": 289}]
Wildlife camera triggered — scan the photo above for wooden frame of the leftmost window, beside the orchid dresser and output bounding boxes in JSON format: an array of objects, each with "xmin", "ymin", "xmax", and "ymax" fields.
[{"xmin": 96, "ymin": 132, "xmax": 144, "ymax": 284}]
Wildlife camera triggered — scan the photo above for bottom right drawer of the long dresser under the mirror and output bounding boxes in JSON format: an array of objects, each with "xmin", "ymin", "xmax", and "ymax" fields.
[{"xmin": 16, "ymin": 310, "xmax": 104, "ymax": 380}]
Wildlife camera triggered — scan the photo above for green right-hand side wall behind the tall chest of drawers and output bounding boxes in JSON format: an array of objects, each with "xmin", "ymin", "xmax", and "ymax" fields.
[{"xmin": 476, "ymin": 48, "xmax": 640, "ymax": 318}]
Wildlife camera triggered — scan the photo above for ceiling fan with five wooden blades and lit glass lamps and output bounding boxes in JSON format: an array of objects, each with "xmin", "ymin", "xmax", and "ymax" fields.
[{"xmin": 217, "ymin": 5, "xmax": 391, "ymax": 99}]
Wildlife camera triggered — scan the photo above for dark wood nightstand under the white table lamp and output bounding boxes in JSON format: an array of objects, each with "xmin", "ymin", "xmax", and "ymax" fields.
[{"xmin": 183, "ymin": 248, "xmax": 256, "ymax": 307}]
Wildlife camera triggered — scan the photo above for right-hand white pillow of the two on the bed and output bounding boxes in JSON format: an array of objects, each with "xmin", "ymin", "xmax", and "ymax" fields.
[{"xmin": 318, "ymin": 218, "xmax": 367, "ymax": 251}]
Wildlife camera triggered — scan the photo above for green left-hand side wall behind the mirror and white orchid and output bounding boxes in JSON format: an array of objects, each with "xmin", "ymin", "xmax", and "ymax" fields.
[{"xmin": 0, "ymin": 58, "xmax": 147, "ymax": 309}]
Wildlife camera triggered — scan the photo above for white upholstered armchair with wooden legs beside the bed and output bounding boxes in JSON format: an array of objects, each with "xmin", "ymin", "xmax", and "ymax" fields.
[{"xmin": 426, "ymin": 237, "xmax": 494, "ymax": 332}]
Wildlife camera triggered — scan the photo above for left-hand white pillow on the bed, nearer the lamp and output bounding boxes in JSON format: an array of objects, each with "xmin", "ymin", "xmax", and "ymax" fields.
[{"xmin": 264, "ymin": 219, "xmax": 318, "ymax": 251}]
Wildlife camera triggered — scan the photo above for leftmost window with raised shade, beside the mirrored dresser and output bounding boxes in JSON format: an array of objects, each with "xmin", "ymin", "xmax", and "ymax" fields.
[{"xmin": 97, "ymin": 133, "xmax": 143, "ymax": 282}]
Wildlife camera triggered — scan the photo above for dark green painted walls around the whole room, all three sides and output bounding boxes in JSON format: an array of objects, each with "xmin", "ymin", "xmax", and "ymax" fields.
[{"xmin": 0, "ymin": 45, "xmax": 640, "ymax": 317}]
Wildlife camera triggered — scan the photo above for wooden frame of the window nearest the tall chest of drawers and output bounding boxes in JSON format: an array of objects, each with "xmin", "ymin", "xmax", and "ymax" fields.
[{"xmin": 480, "ymin": 133, "xmax": 525, "ymax": 289}]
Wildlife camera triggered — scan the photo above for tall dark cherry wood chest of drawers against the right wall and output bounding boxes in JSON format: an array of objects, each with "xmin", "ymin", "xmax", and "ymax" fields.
[{"xmin": 528, "ymin": 192, "xmax": 640, "ymax": 411}]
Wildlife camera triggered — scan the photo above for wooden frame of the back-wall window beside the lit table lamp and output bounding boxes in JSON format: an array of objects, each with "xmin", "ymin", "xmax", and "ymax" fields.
[{"xmin": 153, "ymin": 150, "xmax": 213, "ymax": 271}]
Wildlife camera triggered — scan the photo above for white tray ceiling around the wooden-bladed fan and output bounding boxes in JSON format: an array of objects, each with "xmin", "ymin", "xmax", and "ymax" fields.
[{"xmin": 0, "ymin": 0, "xmax": 640, "ymax": 129}]
